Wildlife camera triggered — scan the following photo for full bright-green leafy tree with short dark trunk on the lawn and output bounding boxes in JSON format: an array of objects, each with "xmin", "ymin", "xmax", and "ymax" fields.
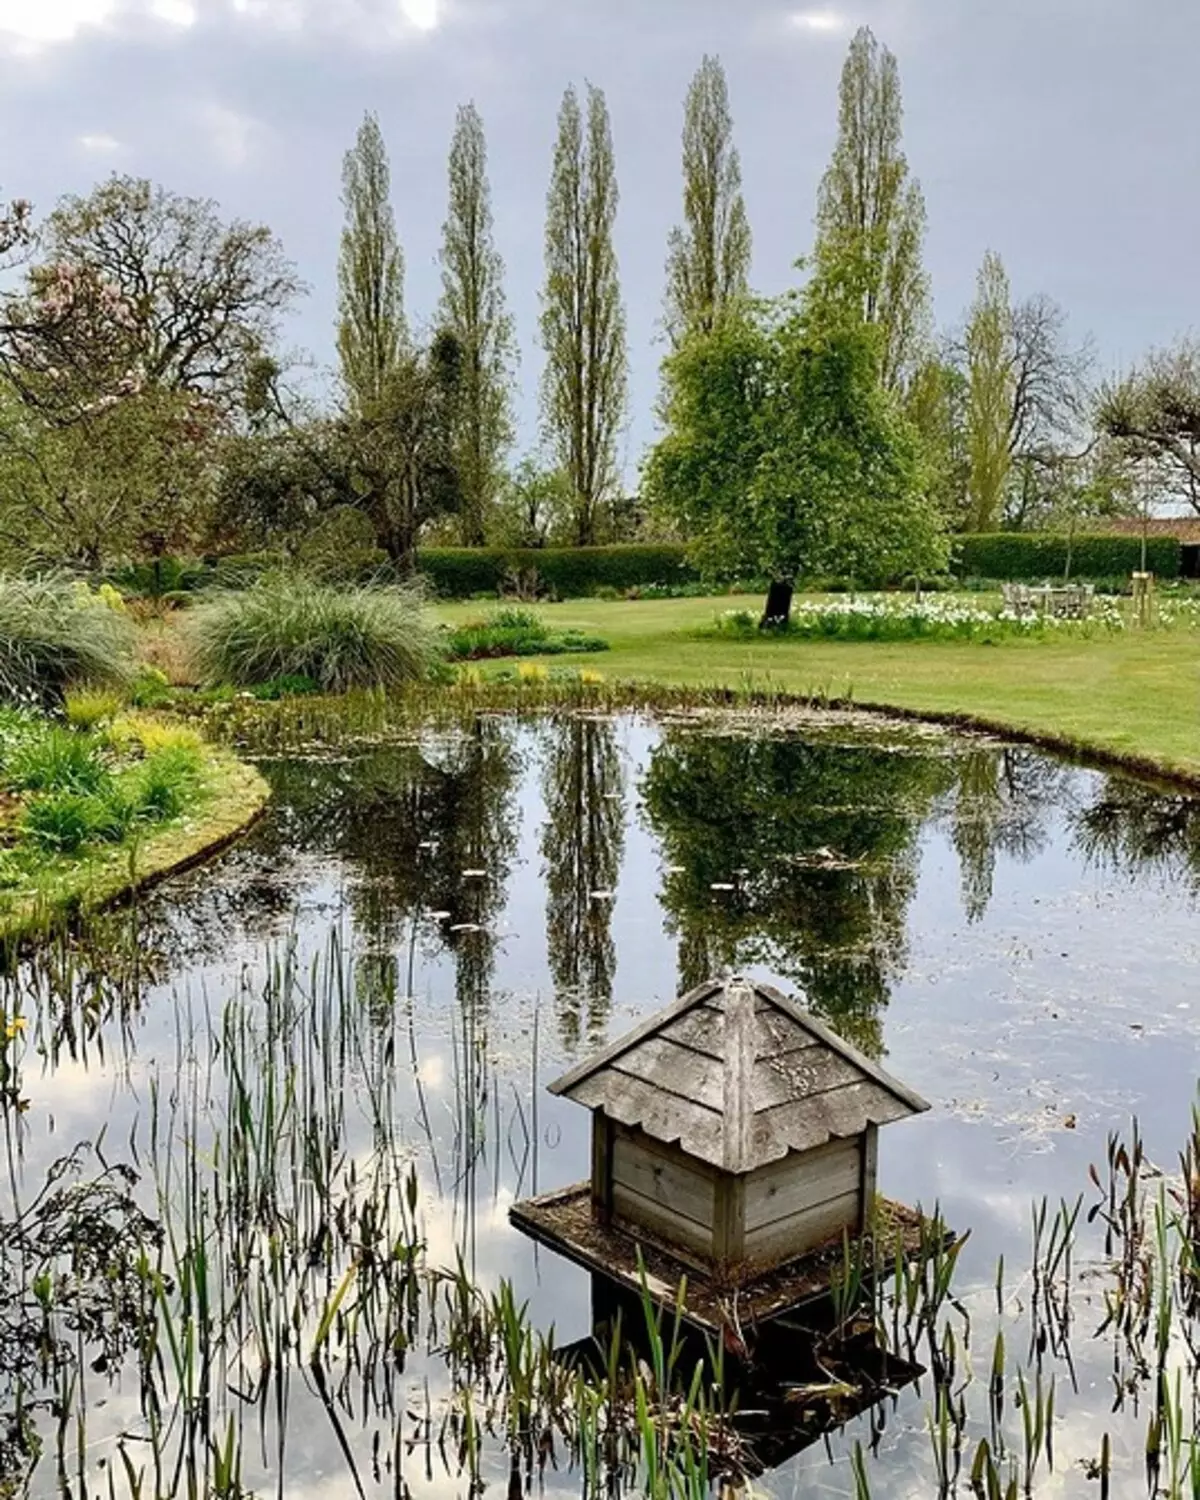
[{"xmin": 647, "ymin": 305, "xmax": 945, "ymax": 626}]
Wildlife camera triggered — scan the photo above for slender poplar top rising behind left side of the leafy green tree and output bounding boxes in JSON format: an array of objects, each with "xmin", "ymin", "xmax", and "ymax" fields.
[{"xmin": 665, "ymin": 57, "xmax": 752, "ymax": 347}]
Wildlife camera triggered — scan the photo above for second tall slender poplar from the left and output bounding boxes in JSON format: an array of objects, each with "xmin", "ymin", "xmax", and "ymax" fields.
[{"xmin": 441, "ymin": 104, "xmax": 516, "ymax": 546}]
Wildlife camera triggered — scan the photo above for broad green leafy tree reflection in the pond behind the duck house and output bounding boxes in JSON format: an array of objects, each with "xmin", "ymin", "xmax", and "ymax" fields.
[{"xmin": 642, "ymin": 731, "xmax": 951, "ymax": 1055}]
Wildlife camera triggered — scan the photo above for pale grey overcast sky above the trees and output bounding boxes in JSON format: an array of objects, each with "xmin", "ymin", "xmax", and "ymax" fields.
[{"xmin": 0, "ymin": 0, "xmax": 1200, "ymax": 462}]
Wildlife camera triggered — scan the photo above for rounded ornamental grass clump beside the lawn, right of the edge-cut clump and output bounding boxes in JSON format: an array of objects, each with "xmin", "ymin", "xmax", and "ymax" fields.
[{"xmin": 192, "ymin": 576, "xmax": 440, "ymax": 693}]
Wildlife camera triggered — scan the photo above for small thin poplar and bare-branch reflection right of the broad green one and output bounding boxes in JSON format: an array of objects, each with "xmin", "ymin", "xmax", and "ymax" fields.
[{"xmin": 950, "ymin": 746, "xmax": 1073, "ymax": 923}]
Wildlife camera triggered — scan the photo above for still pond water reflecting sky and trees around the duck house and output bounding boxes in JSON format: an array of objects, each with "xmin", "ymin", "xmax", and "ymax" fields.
[{"xmin": 11, "ymin": 716, "xmax": 1200, "ymax": 1496}]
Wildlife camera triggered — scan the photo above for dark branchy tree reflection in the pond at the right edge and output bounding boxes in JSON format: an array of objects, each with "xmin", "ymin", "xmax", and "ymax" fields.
[{"xmin": 1073, "ymin": 776, "xmax": 1200, "ymax": 893}]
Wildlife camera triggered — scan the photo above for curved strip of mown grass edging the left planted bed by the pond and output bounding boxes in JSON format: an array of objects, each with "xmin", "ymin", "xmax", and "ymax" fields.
[{"xmin": 0, "ymin": 746, "xmax": 270, "ymax": 948}]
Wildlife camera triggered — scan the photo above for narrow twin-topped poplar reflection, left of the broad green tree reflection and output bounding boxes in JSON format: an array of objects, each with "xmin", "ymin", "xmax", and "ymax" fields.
[{"xmin": 542, "ymin": 717, "xmax": 626, "ymax": 1047}]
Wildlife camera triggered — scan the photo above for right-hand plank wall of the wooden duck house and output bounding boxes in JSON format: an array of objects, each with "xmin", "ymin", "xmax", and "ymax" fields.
[{"xmin": 744, "ymin": 1137, "xmax": 864, "ymax": 1265}]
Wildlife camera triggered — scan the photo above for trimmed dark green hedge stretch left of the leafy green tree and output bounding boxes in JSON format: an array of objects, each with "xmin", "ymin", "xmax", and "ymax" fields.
[{"xmin": 417, "ymin": 543, "xmax": 699, "ymax": 599}]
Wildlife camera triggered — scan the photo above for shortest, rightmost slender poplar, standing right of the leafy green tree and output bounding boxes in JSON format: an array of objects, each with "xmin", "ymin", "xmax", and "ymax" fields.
[{"xmin": 966, "ymin": 251, "xmax": 1014, "ymax": 531}]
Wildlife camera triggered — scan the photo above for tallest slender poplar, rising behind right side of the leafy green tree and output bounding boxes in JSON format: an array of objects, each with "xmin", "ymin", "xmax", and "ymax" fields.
[{"xmin": 813, "ymin": 27, "xmax": 929, "ymax": 390}]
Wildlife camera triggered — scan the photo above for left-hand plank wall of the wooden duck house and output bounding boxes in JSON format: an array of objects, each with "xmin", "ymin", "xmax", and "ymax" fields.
[{"xmin": 611, "ymin": 1125, "xmax": 716, "ymax": 1259}]
